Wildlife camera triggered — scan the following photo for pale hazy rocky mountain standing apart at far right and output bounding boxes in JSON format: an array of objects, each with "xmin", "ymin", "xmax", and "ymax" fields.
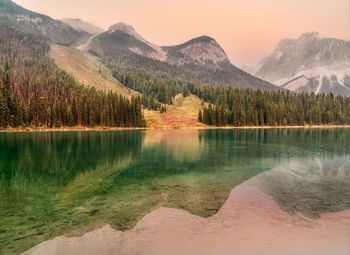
[{"xmin": 256, "ymin": 32, "xmax": 350, "ymax": 95}]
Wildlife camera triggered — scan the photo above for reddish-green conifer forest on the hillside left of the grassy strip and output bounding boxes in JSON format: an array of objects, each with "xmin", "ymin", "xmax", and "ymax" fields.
[{"xmin": 0, "ymin": 26, "xmax": 146, "ymax": 128}]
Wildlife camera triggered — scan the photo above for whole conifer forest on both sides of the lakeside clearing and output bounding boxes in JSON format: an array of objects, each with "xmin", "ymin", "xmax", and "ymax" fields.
[{"xmin": 0, "ymin": 27, "xmax": 350, "ymax": 128}]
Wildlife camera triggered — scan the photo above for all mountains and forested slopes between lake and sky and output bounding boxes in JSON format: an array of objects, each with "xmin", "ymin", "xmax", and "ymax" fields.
[{"xmin": 0, "ymin": 0, "xmax": 350, "ymax": 131}]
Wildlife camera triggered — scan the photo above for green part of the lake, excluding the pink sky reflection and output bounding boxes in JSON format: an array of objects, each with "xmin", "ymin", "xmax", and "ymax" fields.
[{"xmin": 0, "ymin": 129, "xmax": 350, "ymax": 255}]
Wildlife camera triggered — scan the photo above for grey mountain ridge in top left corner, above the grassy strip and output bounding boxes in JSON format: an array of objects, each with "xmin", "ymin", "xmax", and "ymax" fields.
[{"xmin": 0, "ymin": 0, "xmax": 86, "ymax": 45}]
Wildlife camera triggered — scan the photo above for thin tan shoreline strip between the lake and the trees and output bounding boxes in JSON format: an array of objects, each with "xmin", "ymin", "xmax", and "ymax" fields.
[{"xmin": 0, "ymin": 125, "xmax": 350, "ymax": 133}]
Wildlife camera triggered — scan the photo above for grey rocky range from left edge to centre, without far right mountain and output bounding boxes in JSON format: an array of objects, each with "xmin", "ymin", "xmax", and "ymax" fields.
[{"xmin": 0, "ymin": 0, "xmax": 278, "ymax": 90}]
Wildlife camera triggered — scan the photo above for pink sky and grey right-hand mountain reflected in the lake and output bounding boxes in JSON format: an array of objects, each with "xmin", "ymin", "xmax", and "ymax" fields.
[{"xmin": 25, "ymin": 158, "xmax": 350, "ymax": 255}]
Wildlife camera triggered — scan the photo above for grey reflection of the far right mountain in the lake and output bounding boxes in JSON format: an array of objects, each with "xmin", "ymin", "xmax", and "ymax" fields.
[{"xmin": 259, "ymin": 157, "xmax": 350, "ymax": 218}]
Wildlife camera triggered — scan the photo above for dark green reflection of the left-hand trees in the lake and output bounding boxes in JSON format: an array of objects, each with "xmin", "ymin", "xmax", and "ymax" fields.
[{"xmin": 0, "ymin": 132, "xmax": 144, "ymax": 185}]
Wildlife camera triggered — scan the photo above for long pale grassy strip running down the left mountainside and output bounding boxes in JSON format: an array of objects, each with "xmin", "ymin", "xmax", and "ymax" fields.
[{"xmin": 50, "ymin": 45, "xmax": 138, "ymax": 97}]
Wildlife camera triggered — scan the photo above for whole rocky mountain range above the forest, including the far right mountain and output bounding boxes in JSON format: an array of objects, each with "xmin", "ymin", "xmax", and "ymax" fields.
[{"xmin": 0, "ymin": 0, "xmax": 350, "ymax": 95}]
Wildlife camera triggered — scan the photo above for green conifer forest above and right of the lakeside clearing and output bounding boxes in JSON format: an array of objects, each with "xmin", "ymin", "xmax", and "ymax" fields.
[{"xmin": 113, "ymin": 63, "xmax": 350, "ymax": 126}]
